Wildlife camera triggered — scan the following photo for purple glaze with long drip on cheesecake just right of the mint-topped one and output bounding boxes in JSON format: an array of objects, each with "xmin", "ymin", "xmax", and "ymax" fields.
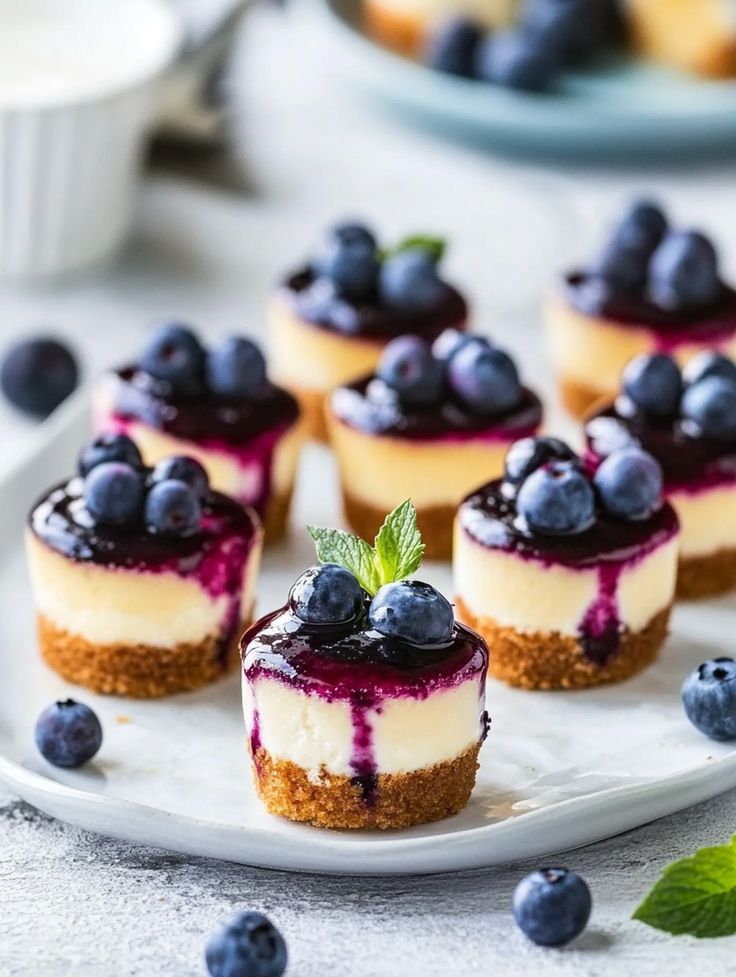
[{"xmin": 460, "ymin": 481, "xmax": 678, "ymax": 665}]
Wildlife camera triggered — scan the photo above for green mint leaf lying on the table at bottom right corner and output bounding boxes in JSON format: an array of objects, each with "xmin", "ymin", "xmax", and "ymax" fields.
[{"xmin": 633, "ymin": 837, "xmax": 736, "ymax": 937}]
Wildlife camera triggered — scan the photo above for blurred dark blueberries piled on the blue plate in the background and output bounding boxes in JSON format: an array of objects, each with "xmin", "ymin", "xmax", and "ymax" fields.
[{"xmin": 426, "ymin": 0, "xmax": 618, "ymax": 91}]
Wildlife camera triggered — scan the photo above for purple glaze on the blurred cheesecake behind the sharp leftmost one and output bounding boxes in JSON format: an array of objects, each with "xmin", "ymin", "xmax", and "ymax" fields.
[{"xmin": 104, "ymin": 367, "xmax": 299, "ymax": 515}]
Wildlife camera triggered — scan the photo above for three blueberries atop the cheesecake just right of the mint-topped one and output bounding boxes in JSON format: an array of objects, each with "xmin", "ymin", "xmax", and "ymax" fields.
[{"xmin": 501, "ymin": 437, "xmax": 662, "ymax": 536}]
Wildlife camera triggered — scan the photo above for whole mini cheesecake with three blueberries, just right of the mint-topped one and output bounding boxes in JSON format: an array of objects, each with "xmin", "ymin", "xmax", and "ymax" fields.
[{"xmin": 454, "ymin": 438, "xmax": 679, "ymax": 689}]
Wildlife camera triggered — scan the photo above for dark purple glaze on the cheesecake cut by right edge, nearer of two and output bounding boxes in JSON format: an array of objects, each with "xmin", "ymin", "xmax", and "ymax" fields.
[{"xmin": 585, "ymin": 396, "xmax": 736, "ymax": 494}]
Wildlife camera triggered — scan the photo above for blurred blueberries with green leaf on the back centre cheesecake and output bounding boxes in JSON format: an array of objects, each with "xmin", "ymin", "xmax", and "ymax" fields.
[{"xmin": 300, "ymin": 222, "xmax": 448, "ymax": 316}]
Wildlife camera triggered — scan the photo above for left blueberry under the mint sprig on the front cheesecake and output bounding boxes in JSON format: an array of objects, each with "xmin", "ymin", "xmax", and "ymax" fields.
[{"xmin": 289, "ymin": 563, "xmax": 365, "ymax": 624}]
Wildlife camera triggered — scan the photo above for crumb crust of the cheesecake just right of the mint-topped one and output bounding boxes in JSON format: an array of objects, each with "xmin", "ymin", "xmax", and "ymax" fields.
[{"xmin": 455, "ymin": 597, "xmax": 671, "ymax": 689}]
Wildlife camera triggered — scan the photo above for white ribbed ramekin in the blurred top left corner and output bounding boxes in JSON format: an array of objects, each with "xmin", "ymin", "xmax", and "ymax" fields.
[{"xmin": 0, "ymin": 0, "xmax": 180, "ymax": 278}]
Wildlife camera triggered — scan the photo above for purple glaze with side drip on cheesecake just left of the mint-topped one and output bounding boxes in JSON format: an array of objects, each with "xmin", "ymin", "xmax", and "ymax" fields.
[{"xmin": 29, "ymin": 478, "xmax": 258, "ymax": 664}]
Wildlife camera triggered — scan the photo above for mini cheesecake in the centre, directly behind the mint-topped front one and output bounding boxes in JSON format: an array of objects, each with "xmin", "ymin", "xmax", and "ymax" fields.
[{"xmin": 328, "ymin": 330, "xmax": 542, "ymax": 559}]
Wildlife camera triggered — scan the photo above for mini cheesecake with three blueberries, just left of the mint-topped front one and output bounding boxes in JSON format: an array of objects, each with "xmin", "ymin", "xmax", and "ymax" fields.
[{"xmin": 26, "ymin": 435, "xmax": 262, "ymax": 698}]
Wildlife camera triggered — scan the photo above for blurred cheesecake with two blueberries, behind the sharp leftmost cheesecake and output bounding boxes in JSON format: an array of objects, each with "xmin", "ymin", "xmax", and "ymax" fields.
[{"xmin": 93, "ymin": 324, "xmax": 306, "ymax": 540}]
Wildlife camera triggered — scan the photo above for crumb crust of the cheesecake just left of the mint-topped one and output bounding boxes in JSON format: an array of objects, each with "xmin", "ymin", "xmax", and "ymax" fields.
[{"xmin": 36, "ymin": 614, "xmax": 250, "ymax": 699}]
